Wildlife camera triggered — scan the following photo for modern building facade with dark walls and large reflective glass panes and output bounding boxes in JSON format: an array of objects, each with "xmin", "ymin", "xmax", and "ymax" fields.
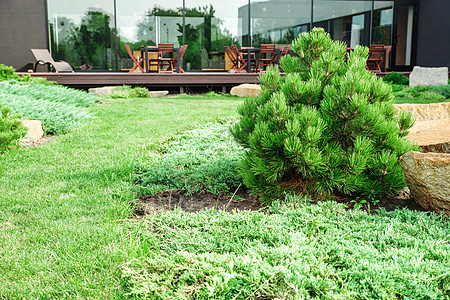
[{"xmin": 0, "ymin": 0, "xmax": 450, "ymax": 71}]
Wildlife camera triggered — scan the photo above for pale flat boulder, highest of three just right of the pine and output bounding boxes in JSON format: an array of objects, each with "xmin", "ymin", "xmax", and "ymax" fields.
[{"xmin": 395, "ymin": 102, "xmax": 450, "ymax": 121}]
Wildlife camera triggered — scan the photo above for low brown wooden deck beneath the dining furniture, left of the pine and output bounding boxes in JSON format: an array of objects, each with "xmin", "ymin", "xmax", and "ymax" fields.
[{"xmin": 18, "ymin": 72, "xmax": 259, "ymax": 90}]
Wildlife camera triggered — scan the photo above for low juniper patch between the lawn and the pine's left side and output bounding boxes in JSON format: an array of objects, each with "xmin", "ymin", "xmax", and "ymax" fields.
[{"xmin": 135, "ymin": 123, "xmax": 242, "ymax": 194}]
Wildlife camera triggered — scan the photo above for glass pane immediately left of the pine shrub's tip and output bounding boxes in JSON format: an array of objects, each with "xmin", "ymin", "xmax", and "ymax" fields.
[{"xmin": 250, "ymin": 0, "xmax": 311, "ymax": 47}]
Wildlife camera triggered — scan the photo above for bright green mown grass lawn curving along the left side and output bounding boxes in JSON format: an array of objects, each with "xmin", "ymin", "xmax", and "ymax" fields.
[{"xmin": 0, "ymin": 98, "xmax": 241, "ymax": 299}]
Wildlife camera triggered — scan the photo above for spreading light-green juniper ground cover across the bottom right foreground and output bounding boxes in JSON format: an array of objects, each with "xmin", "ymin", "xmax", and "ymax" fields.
[{"xmin": 121, "ymin": 198, "xmax": 450, "ymax": 300}]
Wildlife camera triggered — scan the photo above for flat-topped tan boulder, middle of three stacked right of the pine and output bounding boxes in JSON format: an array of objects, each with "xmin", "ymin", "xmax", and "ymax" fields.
[{"xmin": 406, "ymin": 119, "xmax": 450, "ymax": 153}]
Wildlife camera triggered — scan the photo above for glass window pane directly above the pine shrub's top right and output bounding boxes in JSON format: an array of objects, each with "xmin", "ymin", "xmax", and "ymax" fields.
[{"xmin": 313, "ymin": 0, "xmax": 372, "ymax": 48}]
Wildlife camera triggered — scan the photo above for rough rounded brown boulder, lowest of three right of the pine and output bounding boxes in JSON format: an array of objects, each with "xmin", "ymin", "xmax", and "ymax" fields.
[{"xmin": 400, "ymin": 151, "xmax": 450, "ymax": 215}]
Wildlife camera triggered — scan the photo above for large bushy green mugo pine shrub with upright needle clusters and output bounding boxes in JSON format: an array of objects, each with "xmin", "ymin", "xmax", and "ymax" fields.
[{"xmin": 232, "ymin": 28, "xmax": 418, "ymax": 201}]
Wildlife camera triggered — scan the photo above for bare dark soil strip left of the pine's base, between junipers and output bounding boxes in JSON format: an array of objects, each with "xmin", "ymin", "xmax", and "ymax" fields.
[{"xmin": 135, "ymin": 188, "xmax": 264, "ymax": 215}]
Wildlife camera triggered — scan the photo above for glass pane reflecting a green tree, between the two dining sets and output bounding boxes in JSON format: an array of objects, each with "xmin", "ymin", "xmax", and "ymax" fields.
[{"xmin": 184, "ymin": 0, "xmax": 248, "ymax": 70}]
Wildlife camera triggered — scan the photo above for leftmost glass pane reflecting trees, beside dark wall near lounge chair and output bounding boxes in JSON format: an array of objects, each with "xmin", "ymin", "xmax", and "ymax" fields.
[{"xmin": 47, "ymin": 0, "xmax": 116, "ymax": 70}]
